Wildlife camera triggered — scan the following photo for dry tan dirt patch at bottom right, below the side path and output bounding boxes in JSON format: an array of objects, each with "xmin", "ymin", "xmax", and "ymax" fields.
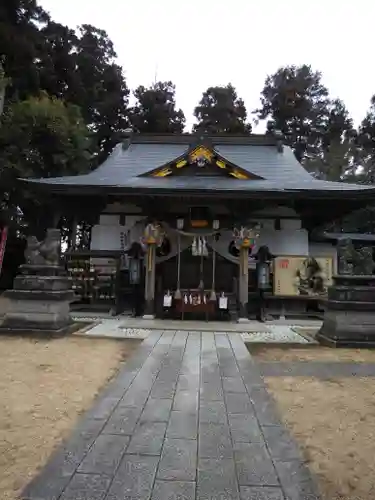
[{"xmin": 266, "ymin": 377, "xmax": 375, "ymax": 500}]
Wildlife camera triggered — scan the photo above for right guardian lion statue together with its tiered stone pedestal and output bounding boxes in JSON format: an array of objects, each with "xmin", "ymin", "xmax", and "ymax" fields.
[{"xmin": 316, "ymin": 241, "xmax": 375, "ymax": 348}]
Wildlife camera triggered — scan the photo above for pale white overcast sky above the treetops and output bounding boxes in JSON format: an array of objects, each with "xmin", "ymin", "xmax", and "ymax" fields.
[{"xmin": 39, "ymin": 0, "xmax": 375, "ymax": 130}]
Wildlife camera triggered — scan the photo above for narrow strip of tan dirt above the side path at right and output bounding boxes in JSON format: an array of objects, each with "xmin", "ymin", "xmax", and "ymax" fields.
[{"xmin": 249, "ymin": 346, "xmax": 375, "ymax": 363}]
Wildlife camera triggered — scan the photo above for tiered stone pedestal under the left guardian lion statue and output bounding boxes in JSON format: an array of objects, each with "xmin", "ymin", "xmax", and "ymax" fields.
[{"xmin": 0, "ymin": 264, "xmax": 74, "ymax": 334}]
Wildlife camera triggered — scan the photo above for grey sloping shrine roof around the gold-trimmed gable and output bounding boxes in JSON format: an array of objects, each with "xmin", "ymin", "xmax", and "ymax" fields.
[{"xmin": 21, "ymin": 134, "xmax": 374, "ymax": 198}]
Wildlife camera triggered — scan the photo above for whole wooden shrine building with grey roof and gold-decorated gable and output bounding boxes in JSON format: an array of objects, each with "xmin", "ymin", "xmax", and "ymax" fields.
[{"xmin": 22, "ymin": 132, "xmax": 375, "ymax": 320}]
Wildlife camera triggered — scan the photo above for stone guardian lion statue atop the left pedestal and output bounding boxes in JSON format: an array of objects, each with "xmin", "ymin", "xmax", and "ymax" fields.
[{"xmin": 25, "ymin": 229, "xmax": 61, "ymax": 266}]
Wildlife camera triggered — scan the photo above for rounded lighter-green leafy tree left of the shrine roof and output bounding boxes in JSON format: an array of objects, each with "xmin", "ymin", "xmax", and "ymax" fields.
[{"xmin": 0, "ymin": 95, "xmax": 91, "ymax": 234}]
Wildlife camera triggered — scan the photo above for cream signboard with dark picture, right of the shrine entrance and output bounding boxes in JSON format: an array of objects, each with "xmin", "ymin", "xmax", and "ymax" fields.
[{"xmin": 273, "ymin": 256, "xmax": 333, "ymax": 298}]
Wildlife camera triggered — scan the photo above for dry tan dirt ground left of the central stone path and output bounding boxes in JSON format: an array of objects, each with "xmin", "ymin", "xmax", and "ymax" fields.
[{"xmin": 0, "ymin": 337, "xmax": 139, "ymax": 500}]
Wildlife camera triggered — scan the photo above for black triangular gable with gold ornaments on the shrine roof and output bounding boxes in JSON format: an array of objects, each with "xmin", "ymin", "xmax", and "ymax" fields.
[{"xmin": 144, "ymin": 145, "xmax": 262, "ymax": 180}]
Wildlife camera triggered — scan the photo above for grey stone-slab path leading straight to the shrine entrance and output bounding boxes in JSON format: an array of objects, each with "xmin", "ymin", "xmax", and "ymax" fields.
[{"xmin": 23, "ymin": 331, "xmax": 318, "ymax": 500}]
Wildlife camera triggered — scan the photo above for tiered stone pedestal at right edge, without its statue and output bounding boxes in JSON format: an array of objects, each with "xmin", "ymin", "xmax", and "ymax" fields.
[{"xmin": 316, "ymin": 275, "xmax": 375, "ymax": 348}]
